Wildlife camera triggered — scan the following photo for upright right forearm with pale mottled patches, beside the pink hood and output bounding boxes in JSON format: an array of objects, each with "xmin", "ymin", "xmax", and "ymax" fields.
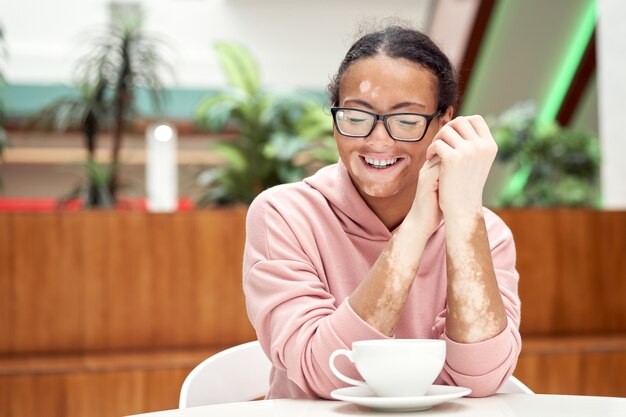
[{"xmin": 444, "ymin": 209, "xmax": 507, "ymax": 343}]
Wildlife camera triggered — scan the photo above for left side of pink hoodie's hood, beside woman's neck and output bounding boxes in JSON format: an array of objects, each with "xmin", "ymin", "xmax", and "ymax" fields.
[{"xmin": 304, "ymin": 161, "xmax": 391, "ymax": 241}]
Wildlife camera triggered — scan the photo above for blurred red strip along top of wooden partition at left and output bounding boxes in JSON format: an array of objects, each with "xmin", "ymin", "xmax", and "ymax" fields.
[{"xmin": 0, "ymin": 198, "xmax": 194, "ymax": 212}]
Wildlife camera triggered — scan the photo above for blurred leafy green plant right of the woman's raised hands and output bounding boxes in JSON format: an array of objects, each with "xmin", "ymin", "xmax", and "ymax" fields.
[{"xmin": 488, "ymin": 103, "xmax": 600, "ymax": 207}]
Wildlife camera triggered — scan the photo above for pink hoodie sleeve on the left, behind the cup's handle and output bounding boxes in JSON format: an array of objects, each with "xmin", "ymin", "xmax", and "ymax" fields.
[{"xmin": 243, "ymin": 192, "xmax": 386, "ymax": 398}]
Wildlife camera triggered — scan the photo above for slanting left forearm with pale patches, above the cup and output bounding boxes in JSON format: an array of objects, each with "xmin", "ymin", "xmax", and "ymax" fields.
[{"xmin": 349, "ymin": 215, "xmax": 429, "ymax": 336}]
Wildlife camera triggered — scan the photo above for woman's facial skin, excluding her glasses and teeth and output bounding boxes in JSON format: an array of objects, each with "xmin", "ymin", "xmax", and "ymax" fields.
[{"xmin": 334, "ymin": 55, "xmax": 449, "ymax": 202}]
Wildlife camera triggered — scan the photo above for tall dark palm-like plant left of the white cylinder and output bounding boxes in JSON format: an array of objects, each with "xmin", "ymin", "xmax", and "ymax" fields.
[{"xmin": 37, "ymin": 13, "xmax": 171, "ymax": 207}]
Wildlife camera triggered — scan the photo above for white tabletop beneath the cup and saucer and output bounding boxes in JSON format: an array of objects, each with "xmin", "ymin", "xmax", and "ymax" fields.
[{"xmin": 128, "ymin": 394, "xmax": 626, "ymax": 417}]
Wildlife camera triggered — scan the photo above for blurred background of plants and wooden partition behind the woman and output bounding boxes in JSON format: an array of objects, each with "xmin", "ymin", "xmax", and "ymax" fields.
[{"xmin": 0, "ymin": 0, "xmax": 626, "ymax": 416}]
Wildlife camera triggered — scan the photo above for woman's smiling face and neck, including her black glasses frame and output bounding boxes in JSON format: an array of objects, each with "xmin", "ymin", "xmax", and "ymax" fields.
[{"xmin": 333, "ymin": 55, "xmax": 451, "ymax": 229}]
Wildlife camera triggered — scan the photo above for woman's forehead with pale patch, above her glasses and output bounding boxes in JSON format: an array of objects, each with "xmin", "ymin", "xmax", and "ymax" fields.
[{"xmin": 339, "ymin": 55, "xmax": 437, "ymax": 108}]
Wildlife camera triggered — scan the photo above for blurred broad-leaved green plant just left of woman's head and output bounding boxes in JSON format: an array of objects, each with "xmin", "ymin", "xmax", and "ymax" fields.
[{"xmin": 196, "ymin": 42, "xmax": 338, "ymax": 205}]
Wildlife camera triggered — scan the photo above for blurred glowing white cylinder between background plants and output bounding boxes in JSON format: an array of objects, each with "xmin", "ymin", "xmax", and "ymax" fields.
[{"xmin": 146, "ymin": 123, "xmax": 178, "ymax": 212}]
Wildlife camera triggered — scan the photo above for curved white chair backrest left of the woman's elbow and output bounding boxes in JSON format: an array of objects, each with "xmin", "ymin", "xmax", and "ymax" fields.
[{"xmin": 178, "ymin": 341, "xmax": 272, "ymax": 408}]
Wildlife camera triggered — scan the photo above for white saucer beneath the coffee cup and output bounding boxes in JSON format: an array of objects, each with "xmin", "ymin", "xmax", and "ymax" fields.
[{"xmin": 330, "ymin": 385, "xmax": 472, "ymax": 411}]
